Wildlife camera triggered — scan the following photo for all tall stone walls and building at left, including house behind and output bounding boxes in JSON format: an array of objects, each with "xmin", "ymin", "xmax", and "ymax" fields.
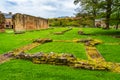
[{"xmin": 0, "ymin": 12, "xmax": 48, "ymax": 32}]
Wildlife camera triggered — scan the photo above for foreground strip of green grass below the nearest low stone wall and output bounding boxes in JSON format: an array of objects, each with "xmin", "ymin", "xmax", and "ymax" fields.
[{"xmin": 0, "ymin": 60, "xmax": 120, "ymax": 80}]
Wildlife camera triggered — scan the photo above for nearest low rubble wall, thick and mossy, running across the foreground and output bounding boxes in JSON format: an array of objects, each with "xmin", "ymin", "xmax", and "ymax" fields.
[{"xmin": 15, "ymin": 52, "xmax": 109, "ymax": 70}]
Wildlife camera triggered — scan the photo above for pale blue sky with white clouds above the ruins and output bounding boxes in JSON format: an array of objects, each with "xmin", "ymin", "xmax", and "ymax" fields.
[{"xmin": 0, "ymin": 0, "xmax": 77, "ymax": 18}]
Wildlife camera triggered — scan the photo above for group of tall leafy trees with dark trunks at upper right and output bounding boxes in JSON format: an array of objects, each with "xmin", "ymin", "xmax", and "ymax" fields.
[{"xmin": 74, "ymin": 0, "xmax": 120, "ymax": 29}]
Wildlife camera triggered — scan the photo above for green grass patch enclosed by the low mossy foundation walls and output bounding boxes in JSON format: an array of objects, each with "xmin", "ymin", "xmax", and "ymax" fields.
[{"xmin": 28, "ymin": 42, "xmax": 87, "ymax": 59}]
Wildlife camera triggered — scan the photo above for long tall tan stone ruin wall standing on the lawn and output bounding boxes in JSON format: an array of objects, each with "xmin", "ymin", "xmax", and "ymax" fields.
[{"xmin": 12, "ymin": 13, "xmax": 48, "ymax": 32}]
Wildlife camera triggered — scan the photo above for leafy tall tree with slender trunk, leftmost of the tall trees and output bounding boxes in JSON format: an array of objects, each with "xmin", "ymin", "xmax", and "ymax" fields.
[{"xmin": 74, "ymin": 0, "xmax": 100, "ymax": 27}]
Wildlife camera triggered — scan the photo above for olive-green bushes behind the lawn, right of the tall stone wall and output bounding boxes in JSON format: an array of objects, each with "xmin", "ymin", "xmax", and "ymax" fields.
[{"xmin": 49, "ymin": 17, "xmax": 92, "ymax": 27}]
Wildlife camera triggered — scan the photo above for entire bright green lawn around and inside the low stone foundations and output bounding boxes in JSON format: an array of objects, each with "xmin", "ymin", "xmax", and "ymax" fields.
[{"xmin": 0, "ymin": 28, "xmax": 120, "ymax": 80}]
